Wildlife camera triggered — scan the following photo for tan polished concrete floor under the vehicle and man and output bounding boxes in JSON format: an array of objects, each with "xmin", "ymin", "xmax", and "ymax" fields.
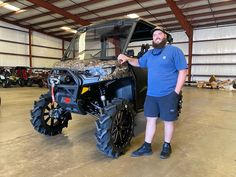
[{"xmin": 0, "ymin": 87, "xmax": 236, "ymax": 177}]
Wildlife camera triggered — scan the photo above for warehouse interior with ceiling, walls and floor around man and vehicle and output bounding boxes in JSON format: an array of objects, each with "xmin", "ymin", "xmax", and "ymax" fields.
[{"xmin": 0, "ymin": 0, "xmax": 236, "ymax": 177}]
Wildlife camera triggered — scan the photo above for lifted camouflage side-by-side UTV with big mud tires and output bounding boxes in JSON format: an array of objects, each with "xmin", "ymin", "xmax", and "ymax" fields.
[{"xmin": 31, "ymin": 19, "xmax": 182, "ymax": 158}]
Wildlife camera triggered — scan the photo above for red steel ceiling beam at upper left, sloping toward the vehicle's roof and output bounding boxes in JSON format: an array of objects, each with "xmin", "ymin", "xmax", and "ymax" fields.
[{"xmin": 27, "ymin": 0, "xmax": 90, "ymax": 26}]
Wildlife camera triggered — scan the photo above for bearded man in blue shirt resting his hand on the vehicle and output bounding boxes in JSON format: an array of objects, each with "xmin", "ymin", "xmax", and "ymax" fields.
[{"xmin": 118, "ymin": 27, "xmax": 187, "ymax": 159}]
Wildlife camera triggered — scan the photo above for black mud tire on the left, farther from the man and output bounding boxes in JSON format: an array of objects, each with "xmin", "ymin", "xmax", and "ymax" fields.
[{"xmin": 30, "ymin": 93, "xmax": 71, "ymax": 136}]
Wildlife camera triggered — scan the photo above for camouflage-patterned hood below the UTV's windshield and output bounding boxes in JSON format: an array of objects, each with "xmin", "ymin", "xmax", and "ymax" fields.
[{"xmin": 54, "ymin": 59, "xmax": 131, "ymax": 81}]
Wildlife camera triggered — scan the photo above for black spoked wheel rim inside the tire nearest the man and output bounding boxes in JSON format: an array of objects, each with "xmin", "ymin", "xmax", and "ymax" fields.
[{"xmin": 111, "ymin": 108, "xmax": 133, "ymax": 149}]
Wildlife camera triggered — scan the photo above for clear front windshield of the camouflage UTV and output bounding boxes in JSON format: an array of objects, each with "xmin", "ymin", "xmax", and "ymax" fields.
[{"xmin": 63, "ymin": 23, "xmax": 133, "ymax": 60}]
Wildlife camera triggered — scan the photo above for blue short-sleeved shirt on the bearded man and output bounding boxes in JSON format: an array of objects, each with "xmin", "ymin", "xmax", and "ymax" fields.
[{"xmin": 138, "ymin": 45, "xmax": 188, "ymax": 97}]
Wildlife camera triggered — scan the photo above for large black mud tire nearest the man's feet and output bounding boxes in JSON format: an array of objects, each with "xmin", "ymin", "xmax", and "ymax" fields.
[{"xmin": 95, "ymin": 99, "xmax": 134, "ymax": 158}]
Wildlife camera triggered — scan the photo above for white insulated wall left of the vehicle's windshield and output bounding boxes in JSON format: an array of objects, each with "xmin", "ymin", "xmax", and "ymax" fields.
[{"xmin": 0, "ymin": 21, "xmax": 62, "ymax": 68}]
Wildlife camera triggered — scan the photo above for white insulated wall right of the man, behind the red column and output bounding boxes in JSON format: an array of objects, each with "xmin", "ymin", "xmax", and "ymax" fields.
[{"xmin": 173, "ymin": 26, "xmax": 236, "ymax": 81}]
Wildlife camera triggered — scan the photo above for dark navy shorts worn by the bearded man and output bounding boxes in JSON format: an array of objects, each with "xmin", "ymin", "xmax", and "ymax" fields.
[{"xmin": 144, "ymin": 91, "xmax": 180, "ymax": 121}]
